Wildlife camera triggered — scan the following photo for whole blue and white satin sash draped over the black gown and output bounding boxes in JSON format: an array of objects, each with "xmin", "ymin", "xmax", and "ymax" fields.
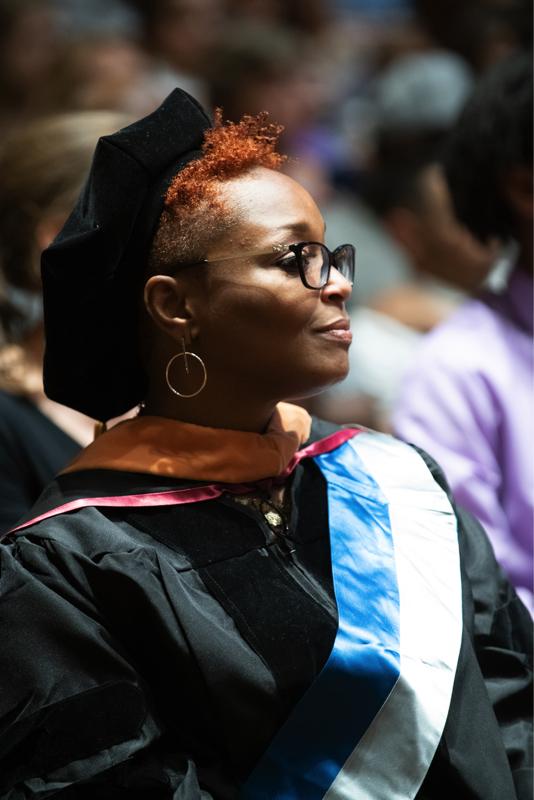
[{"xmin": 241, "ymin": 432, "xmax": 462, "ymax": 800}]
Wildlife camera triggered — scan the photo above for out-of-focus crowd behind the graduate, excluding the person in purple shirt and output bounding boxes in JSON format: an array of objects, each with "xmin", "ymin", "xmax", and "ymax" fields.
[{"xmin": 0, "ymin": 0, "xmax": 532, "ymax": 600}]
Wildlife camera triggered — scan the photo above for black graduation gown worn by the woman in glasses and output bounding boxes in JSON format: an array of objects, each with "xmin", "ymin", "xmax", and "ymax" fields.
[{"xmin": 0, "ymin": 424, "xmax": 532, "ymax": 800}]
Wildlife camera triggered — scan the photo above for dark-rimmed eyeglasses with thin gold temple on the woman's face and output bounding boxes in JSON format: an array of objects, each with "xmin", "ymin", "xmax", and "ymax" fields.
[{"xmin": 177, "ymin": 242, "xmax": 356, "ymax": 289}]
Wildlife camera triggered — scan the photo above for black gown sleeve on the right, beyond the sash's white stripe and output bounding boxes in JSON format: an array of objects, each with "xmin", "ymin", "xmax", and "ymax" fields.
[{"xmin": 416, "ymin": 448, "xmax": 533, "ymax": 800}]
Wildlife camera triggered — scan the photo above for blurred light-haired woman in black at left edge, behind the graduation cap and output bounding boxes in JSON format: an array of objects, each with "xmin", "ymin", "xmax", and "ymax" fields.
[{"xmin": 0, "ymin": 111, "xmax": 129, "ymax": 532}]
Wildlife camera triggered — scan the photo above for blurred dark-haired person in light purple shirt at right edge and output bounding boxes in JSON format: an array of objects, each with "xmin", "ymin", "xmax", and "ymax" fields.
[{"xmin": 393, "ymin": 54, "xmax": 534, "ymax": 611}]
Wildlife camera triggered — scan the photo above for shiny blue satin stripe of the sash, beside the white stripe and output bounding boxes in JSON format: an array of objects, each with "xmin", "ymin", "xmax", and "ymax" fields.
[{"xmin": 241, "ymin": 440, "xmax": 400, "ymax": 800}]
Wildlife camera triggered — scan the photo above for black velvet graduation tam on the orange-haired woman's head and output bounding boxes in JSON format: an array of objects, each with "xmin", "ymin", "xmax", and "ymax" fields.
[{"xmin": 41, "ymin": 89, "xmax": 211, "ymax": 420}]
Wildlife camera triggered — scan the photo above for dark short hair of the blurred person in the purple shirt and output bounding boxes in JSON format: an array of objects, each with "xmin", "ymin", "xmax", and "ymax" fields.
[{"xmin": 443, "ymin": 52, "xmax": 532, "ymax": 242}]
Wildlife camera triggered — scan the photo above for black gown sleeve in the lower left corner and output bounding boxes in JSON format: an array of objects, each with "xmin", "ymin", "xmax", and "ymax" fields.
[{"xmin": 0, "ymin": 536, "xmax": 211, "ymax": 800}]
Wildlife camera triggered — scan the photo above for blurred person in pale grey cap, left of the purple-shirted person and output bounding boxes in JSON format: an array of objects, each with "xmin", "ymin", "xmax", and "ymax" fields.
[{"xmin": 362, "ymin": 50, "xmax": 497, "ymax": 294}]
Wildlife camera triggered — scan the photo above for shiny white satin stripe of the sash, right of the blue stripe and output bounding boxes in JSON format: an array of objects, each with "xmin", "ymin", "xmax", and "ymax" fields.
[{"xmin": 324, "ymin": 432, "xmax": 462, "ymax": 800}]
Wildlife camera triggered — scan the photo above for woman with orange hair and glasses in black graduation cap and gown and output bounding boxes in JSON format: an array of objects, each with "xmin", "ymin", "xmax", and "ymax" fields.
[{"xmin": 0, "ymin": 91, "xmax": 530, "ymax": 800}]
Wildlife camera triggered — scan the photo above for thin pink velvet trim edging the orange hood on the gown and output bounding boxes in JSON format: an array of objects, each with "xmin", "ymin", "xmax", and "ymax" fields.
[{"xmin": 9, "ymin": 428, "xmax": 360, "ymax": 533}]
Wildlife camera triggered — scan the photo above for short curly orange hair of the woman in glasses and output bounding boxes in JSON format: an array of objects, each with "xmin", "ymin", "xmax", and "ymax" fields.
[{"xmin": 149, "ymin": 109, "xmax": 285, "ymax": 271}]
